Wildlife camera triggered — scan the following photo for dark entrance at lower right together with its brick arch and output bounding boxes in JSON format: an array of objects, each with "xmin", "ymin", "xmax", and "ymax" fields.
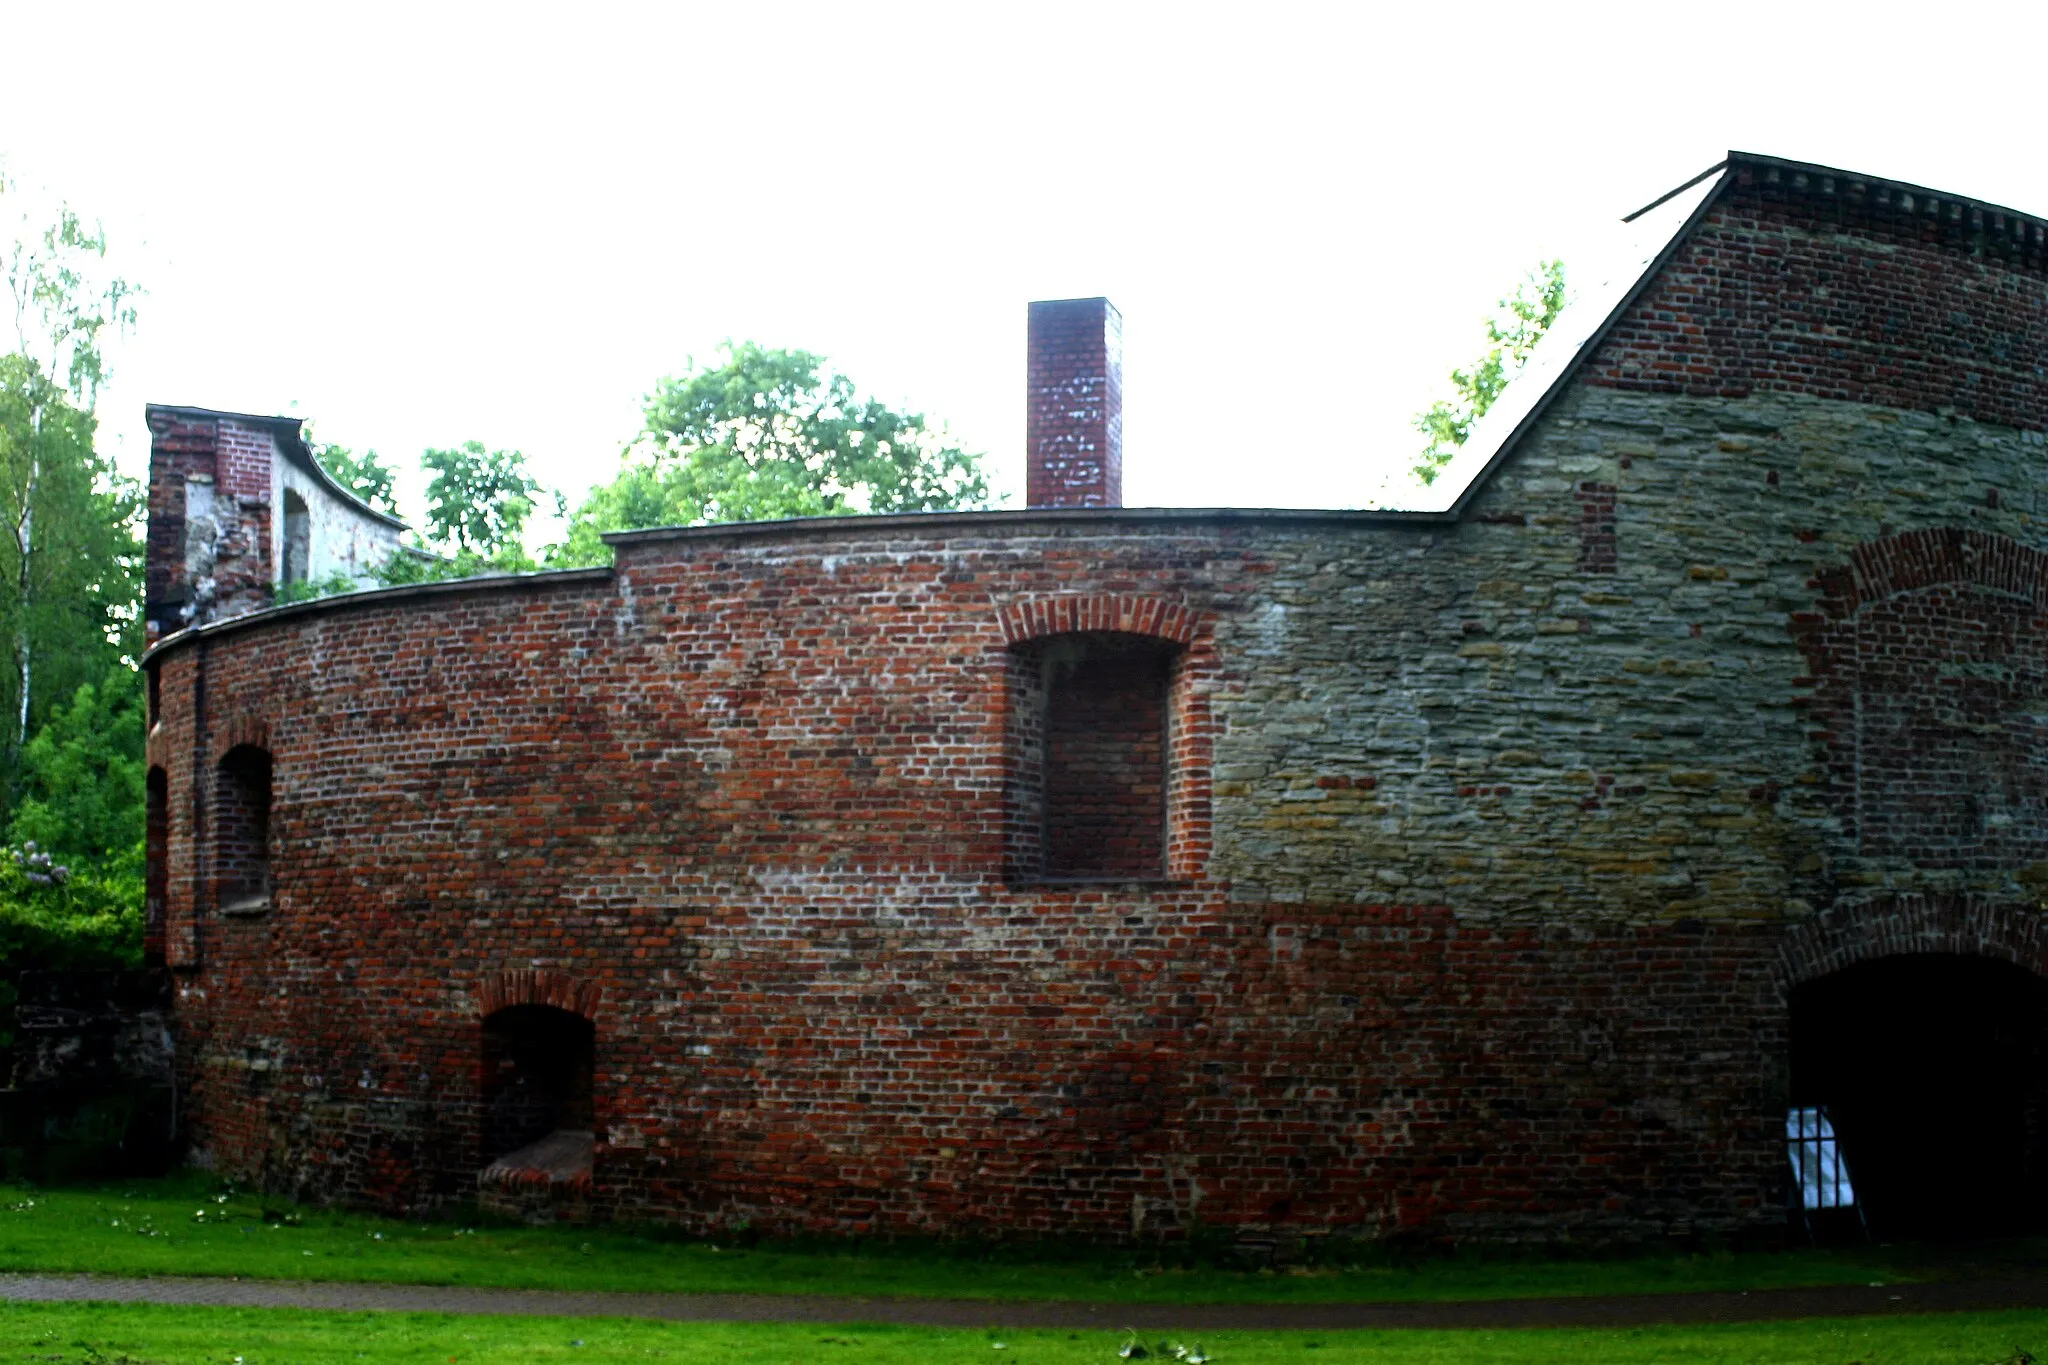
[{"xmin": 1784, "ymin": 896, "xmax": 2048, "ymax": 1236}]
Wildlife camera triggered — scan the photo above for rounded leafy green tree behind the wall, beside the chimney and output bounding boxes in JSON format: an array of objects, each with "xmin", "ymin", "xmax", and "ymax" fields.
[{"xmin": 555, "ymin": 342, "xmax": 989, "ymax": 565}]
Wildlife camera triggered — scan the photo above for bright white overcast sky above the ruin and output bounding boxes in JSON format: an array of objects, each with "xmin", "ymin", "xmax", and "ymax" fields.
[{"xmin": 0, "ymin": 0, "xmax": 2048, "ymax": 527}]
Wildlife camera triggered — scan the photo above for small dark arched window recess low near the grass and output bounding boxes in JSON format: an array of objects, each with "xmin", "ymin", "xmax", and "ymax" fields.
[{"xmin": 481, "ymin": 1005, "xmax": 598, "ymax": 1164}]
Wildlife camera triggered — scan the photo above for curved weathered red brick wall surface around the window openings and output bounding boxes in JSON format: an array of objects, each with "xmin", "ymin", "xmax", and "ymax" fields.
[{"xmin": 152, "ymin": 528, "xmax": 1782, "ymax": 1234}]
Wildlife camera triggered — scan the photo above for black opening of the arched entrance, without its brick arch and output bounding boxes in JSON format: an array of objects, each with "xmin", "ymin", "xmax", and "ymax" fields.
[{"xmin": 1792, "ymin": 954, "xmax": 2048, "ymax": 1236}]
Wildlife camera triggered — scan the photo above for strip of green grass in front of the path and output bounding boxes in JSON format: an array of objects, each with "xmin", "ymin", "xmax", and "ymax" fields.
[{"xmin": 0, "ymin": 1304, "xmax": 2048, "ymax": 1365}]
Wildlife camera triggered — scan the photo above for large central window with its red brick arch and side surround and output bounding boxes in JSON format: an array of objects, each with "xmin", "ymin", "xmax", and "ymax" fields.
[{"xmin": 997, "ymin": 593, "xmax": 1217, "ymax": 882}]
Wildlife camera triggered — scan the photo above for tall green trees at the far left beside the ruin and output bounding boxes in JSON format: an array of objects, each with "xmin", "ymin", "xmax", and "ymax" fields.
[{"xmin": 0, "ymin": 182, "xmax": 143, "ymax": 970}]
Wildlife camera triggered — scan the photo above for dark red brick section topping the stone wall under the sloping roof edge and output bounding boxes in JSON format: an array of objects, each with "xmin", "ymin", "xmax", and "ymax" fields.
[{"xmin": 1581, "ymin": 168, "xmax": 2048, "ymax": 430}]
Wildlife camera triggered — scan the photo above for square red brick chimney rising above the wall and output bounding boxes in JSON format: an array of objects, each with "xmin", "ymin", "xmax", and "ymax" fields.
[{"xmin": 1024, "ymin": 299, "xmax": 1124, "ymax": 508}]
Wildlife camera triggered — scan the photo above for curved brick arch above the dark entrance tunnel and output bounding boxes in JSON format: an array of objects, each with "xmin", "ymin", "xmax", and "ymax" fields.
[{"xmin": 1778, "ymin": 894, "xmax": 2048, "ymax": 995}]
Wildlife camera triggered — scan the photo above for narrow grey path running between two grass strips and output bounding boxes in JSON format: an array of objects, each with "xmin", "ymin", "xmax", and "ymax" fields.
[{"xmin": 0, "ymin": 1275, "xmax": 2048, "ymax": 1332}]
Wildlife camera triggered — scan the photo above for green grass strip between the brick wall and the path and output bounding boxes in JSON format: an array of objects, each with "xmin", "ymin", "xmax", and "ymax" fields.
[{"xmin": 0, "ymin": 1173, "xmax": 1966, "ymax": 1304}]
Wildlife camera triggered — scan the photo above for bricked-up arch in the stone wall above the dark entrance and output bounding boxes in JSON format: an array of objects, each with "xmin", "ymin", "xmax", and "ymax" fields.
[{"xmin": 1790, "ymin": 526, "xmax": 2048, "ymax": 870}]
